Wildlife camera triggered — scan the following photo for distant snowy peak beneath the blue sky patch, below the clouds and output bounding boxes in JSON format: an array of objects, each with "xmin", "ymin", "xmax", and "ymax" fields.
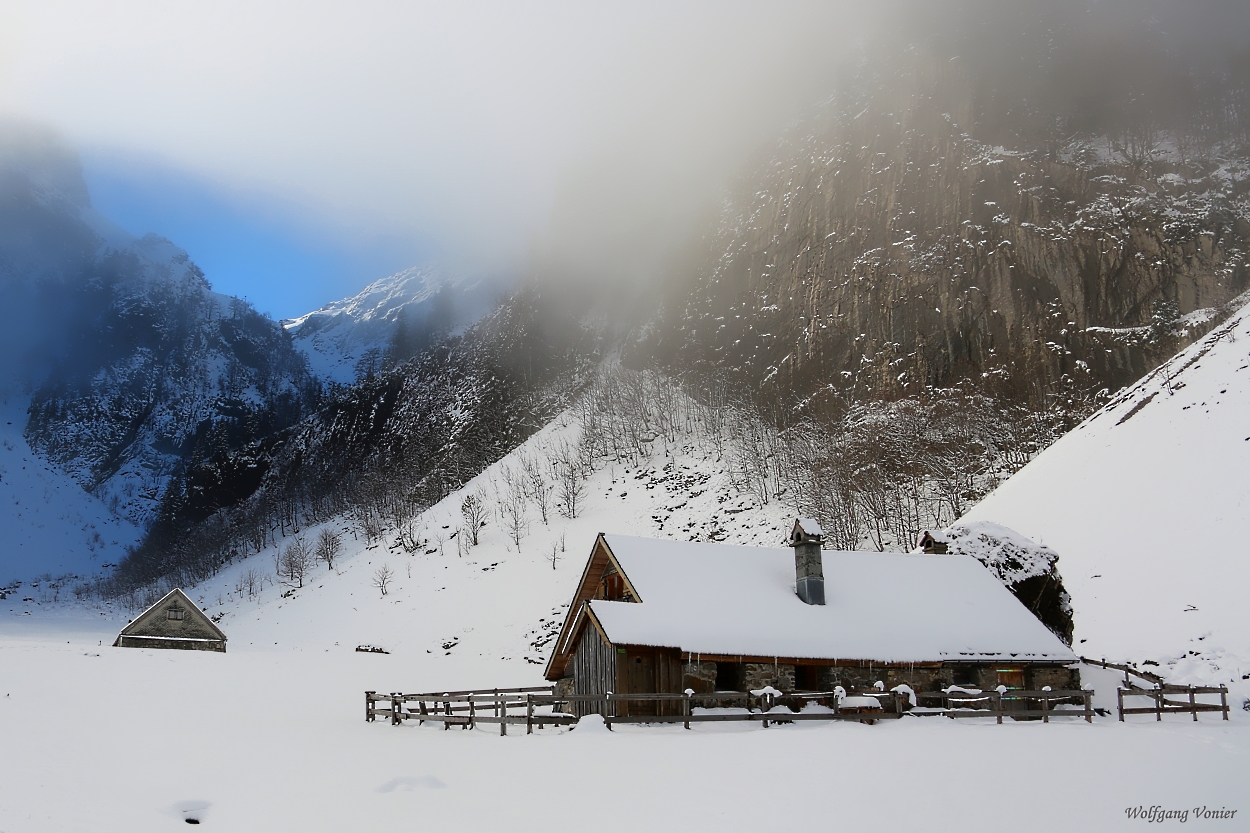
[{"xmin": 281, "ymin": 263, "xmax": 497, "ymax": 384}]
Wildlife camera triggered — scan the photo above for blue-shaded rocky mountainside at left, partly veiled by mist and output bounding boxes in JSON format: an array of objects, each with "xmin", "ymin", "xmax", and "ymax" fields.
[{"xmin": 0, "ymin": 125, "xmax": 319, "ymax": 527}]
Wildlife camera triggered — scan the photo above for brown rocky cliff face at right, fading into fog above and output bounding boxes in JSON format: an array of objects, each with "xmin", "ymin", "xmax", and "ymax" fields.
[{"xmin": 635, "ymin": 61, "xmax": 1250, "ymax": 403}]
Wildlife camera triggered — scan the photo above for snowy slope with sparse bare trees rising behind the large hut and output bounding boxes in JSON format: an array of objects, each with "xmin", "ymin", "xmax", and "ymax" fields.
[{"xmin": 158, "ymin": 400, "xmax": 794, "ymax": 665}]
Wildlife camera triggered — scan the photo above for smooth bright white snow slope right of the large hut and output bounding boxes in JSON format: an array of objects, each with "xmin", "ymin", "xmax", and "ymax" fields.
[{"xmin": 963, "ymin": 296, "xmax": 1250, "ymax": 682}]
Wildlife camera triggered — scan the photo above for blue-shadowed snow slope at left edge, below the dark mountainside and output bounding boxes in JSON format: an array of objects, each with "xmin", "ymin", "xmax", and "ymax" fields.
[{"xmin": 0, "ymin": 393, "xmax": 139, "ymax": 580}]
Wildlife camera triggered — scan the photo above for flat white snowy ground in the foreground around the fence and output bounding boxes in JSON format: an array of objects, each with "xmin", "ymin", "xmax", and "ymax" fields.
[{"xmin": 0, "ymin": 613, "xmax": 1250, "ymax": 833}]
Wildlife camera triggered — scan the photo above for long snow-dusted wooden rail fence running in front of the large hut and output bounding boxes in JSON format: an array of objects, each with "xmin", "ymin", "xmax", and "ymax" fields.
[{"xmin": 365, "ymin": 687, "xmax": 1094, "ymax": 734}]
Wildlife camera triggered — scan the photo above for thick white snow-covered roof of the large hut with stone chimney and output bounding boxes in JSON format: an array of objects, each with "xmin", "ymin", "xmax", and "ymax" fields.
[{"xmin": 589, "ymin": 535, "xmax": 1076, "ymax": 663}]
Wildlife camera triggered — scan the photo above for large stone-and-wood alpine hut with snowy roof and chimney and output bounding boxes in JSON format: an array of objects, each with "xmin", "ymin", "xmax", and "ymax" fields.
[{"xmin": 545, "ymin": 520, "xmax": 1079, "ymax": 710}]
